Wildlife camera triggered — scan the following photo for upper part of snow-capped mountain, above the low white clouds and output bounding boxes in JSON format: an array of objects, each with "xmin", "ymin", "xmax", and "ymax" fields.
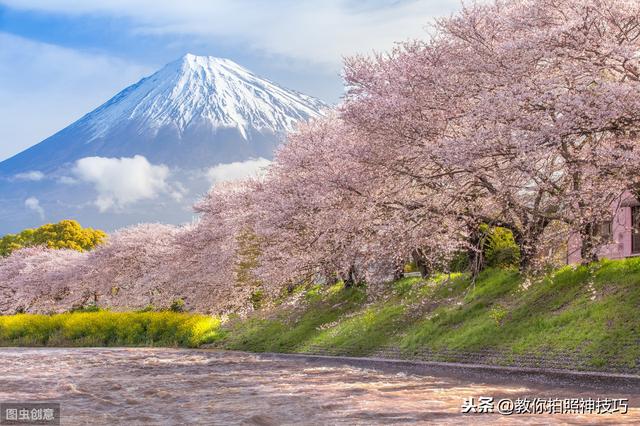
[{"xmin": 0, "ymin": 54, "xmax": 326, "ymax": 176}]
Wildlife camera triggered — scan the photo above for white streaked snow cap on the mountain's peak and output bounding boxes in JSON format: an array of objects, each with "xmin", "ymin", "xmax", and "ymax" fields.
[{"xmin": 74, "ymin": 53, "xmax": 326, "ymax": 142}]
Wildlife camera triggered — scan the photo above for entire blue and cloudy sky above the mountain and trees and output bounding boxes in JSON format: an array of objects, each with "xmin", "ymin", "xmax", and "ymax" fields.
[{"xmin": 0, "ymin": 0, "xmax": 461, "ymax": 161}]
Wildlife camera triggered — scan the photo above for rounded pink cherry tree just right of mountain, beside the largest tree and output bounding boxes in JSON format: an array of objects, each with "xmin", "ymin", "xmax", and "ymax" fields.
[{"xmin": 255, "ymin": 116, "xmax": 468, "ymax": 285}]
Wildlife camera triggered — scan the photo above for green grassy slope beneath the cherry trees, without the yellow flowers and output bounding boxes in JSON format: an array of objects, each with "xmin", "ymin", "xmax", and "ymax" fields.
[{"xmin": 219, "ymin": 259, "xmax": 640, "ymax": 369}]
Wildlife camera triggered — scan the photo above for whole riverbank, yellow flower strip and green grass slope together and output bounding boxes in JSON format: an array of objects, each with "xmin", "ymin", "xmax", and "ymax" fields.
[{"xmin": 0, "ymin": 258, "xmax": 640, "ymax": 372}]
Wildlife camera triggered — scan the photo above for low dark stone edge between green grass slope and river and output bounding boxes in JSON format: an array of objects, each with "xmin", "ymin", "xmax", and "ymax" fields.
[{"xmin": 206, "ymin": 345, "xmax": 640, "ymax": 394}]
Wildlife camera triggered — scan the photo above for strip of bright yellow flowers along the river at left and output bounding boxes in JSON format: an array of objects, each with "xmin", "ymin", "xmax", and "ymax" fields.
[{"xmin": 0, "ymin": 311, "xmax": 220, "ymax": 347}]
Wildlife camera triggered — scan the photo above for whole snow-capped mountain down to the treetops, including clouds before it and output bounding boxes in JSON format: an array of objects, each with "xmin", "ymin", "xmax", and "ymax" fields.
[{"xmin": 0, "ymin": 54, "xmax": 327, "ymax": 233}]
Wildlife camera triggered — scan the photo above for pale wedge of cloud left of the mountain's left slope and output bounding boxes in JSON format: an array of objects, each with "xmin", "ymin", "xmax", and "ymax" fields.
[{"xmin": 0, "ymin": 31, "xmax": 151, "ymax": 161}]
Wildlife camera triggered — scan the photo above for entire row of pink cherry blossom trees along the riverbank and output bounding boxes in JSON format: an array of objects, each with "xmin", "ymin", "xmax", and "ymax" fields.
[{"xmin": 0, "ymin": 0, "xmax": 640, "ymax": 310}]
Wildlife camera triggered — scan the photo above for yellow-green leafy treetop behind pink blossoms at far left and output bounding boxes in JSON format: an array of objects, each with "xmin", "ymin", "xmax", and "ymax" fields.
[{"xmin": 0, "ymin": 220, "xmax": 107, "ymax": 256}]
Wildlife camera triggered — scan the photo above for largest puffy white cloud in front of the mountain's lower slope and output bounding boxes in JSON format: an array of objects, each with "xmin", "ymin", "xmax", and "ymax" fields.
[{"xmin": 73, "ymin": 155, "xmax": 176, "ymax": 212}]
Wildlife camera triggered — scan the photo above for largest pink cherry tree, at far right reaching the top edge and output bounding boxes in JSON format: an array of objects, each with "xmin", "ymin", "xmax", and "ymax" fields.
[{"xmin": 344, "ymin": 0, "xmax": 639, "ymax": 266}]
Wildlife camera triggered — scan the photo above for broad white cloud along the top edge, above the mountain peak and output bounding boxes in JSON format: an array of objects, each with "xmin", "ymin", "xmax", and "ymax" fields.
[{"xmin": 4, "ymin": 0, "xmax": 460, "ymax": 68}]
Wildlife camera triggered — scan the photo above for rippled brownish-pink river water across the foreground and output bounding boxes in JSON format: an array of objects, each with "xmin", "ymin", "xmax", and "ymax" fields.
[{"xmin": 0, "ymin": 348, "xmax": 640, "ymax": 425}]
